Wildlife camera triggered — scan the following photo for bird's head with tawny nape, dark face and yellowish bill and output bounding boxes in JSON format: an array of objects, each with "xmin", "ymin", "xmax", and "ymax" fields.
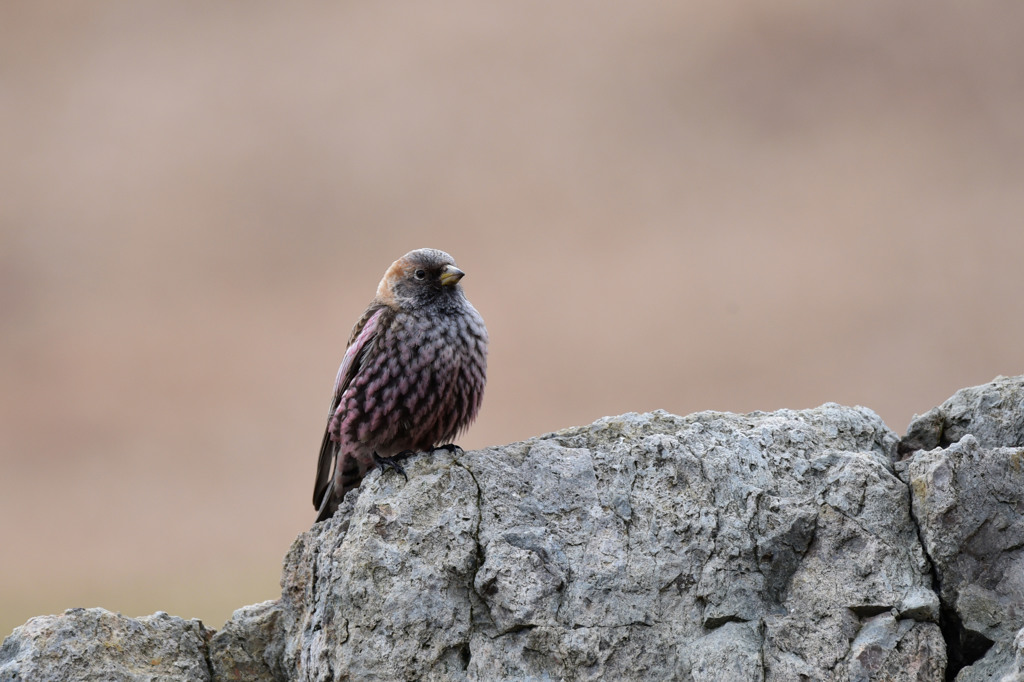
[{"xmin": 377, "ymin": 249, "xmax": 466, "ymax": 307}]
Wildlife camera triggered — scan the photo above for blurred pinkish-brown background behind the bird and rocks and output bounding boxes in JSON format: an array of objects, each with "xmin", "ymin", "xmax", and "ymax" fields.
[{"xmin": 0, "ymin": 0, "xmax": 1024, "ymax": 636}]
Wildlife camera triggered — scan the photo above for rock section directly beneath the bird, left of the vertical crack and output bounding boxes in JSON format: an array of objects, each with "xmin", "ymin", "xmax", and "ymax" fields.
[{"xmin": 272, "ymin": 451, "xmax": 479, "ymax": 680}]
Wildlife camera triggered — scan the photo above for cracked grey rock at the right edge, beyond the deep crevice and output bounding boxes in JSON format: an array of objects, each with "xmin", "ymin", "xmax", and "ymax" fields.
[{"xmin": 897, "ymin": 377, "xmax": 1024, "ymax": 680}]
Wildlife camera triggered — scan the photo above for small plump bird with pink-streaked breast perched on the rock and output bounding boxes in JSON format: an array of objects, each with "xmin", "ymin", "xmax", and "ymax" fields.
[{"xmin": 313, "ymin": 249, "xmax": 487, "ymax": 521}]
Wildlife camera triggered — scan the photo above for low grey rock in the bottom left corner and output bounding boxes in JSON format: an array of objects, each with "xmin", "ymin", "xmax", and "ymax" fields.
[{"xmin": 0, "ymin": 608, "xmax": 212, "ymax": 682}]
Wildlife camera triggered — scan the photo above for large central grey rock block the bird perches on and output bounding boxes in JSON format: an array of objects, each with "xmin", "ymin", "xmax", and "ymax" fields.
[{"xmin": 270, "ymin": 404, "xmax": 944, "ymax": 680}]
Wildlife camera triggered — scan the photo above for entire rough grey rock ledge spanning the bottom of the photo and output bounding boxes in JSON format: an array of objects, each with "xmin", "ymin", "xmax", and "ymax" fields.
[{"xmin": 6, "ymin": 378, "xmax": 1024, "ymax": 682}]
